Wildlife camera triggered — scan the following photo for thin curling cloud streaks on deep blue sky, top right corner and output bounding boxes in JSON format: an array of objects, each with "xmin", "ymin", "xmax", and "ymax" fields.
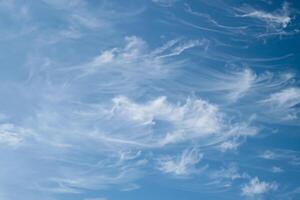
[{"xmin": 183, "ymin": 1, "xmax": 299, "ymax": 40}]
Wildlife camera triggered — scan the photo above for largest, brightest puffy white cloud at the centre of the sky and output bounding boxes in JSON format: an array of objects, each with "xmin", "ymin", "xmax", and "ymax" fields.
[{"xmin": 107, "ymin": 96, "xmax": 258, "ymax": 149}]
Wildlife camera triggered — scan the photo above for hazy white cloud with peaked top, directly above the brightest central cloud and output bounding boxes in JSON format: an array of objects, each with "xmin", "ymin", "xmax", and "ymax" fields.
[{"xmin": 62, "ymin": 36, "xmax": 192, "ymax": 95}]
